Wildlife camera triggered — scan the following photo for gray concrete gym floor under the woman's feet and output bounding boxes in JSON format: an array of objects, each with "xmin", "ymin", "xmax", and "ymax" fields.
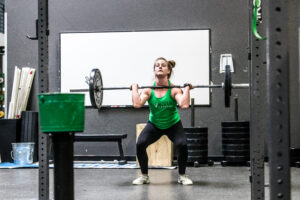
[{"xmin": 0, "ymin": 164, "xmax": 300, "ymax": 200}]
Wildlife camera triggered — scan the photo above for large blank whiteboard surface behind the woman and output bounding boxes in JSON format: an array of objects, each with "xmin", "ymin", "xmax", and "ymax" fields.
[{"xmin": 60, "ymin": 30, "xmax": 210, "ymax": 107}]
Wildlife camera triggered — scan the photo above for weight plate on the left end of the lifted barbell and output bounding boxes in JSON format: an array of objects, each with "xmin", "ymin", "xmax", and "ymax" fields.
[{"xmin": 89, "ymin": 69, "xmax": 103, "ymax": 110}]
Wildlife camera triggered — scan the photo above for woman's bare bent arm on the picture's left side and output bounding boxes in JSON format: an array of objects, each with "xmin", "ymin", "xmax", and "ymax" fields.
[{"xmin": 131, "ymin": 84, "xmax": 151, "ymax": 108}]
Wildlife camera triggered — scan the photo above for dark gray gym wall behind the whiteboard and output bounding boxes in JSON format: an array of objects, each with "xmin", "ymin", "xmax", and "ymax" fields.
[{"xmin": 6, "ymin": 0, "xmax": 300, "ymax": 159}]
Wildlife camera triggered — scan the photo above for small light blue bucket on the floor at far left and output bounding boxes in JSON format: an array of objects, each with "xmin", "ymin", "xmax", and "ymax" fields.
[{"xmin": 11, "ymin": 142, "xmax": 34, "ymax": 165}]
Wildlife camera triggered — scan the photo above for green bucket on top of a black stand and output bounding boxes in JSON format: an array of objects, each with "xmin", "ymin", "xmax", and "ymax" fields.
[{"xmin": 38, "ymin": 93, "xmax": 85, "ymax": 133}]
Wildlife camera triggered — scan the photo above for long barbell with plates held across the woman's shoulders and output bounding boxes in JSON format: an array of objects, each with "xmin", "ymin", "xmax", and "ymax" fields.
[{"xmin": 70, "ymin": 65, "xmax": 249, "ymax": 110}]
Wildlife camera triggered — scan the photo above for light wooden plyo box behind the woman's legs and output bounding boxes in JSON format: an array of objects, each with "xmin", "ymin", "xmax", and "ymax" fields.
[{"xmin": 136, "ymin": 124, "xmax": 173, "ymax": 167}]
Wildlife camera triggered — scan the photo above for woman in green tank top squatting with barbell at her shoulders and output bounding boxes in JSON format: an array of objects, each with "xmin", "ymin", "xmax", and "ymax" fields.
[{"xmin": 131, "ymin": 57, "xmax": 193, "ymax": 185}]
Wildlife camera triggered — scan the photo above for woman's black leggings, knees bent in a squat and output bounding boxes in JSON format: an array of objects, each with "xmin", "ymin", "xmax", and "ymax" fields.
[{"xmin": 136, "ymin": 121, "xmax": 188, "ymax": 174}]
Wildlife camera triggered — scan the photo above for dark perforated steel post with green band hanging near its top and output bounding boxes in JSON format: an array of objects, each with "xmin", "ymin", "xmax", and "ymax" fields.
[{"xmin": 249, "ymin": 0, "xmax": 266, "ymax": 200}]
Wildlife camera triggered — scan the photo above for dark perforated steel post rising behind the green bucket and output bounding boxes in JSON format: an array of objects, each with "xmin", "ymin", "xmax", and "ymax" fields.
[{"xmin": 37, "ymin": 0, "xmax": 49, "ymax": 200}]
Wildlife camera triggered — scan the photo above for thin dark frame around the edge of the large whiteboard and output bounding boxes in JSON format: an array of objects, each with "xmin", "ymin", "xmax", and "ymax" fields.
[{"xmin": 58, "ymin": 28, "xmax": 212, "ymax": 109}]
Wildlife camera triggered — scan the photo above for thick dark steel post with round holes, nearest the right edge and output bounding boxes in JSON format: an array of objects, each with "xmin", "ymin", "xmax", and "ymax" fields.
[{"xmin": 266, "ymin": 0, "xmax": 290, "ymax": 200}]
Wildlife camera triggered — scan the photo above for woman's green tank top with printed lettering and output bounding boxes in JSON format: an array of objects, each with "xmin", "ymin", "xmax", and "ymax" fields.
[{"xmin": 148, "ymin": 81, "xmax": 180, "ymax": 129}]
